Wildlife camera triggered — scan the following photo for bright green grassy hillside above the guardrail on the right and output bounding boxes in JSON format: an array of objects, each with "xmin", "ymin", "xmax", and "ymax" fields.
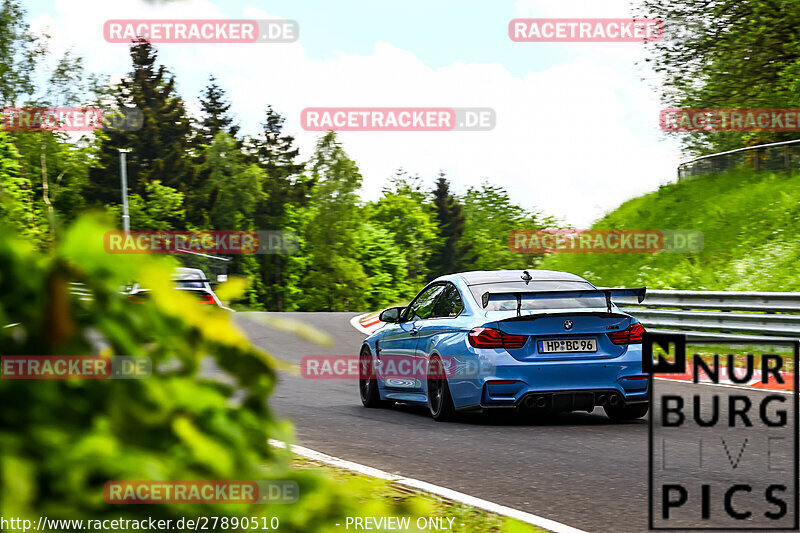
[{"xmin": 541, "ymin": 171, "xmax": 800, "ymax": 291}]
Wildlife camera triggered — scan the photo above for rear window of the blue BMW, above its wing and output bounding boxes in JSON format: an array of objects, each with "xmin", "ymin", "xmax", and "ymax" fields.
[{"xmin": 469, "ymin": 280, "xmax": 606, "ymax": 311}]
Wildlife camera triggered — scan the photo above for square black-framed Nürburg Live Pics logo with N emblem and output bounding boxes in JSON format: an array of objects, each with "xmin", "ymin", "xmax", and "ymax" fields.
[{"xmin": 642, "ymin": 332, "xmax": 800, "ymax": 531}]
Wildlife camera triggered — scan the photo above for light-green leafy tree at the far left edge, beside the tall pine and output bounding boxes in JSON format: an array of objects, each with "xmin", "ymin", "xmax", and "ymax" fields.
[{"xmin": 0, "ymin": 0, "xmax": 95, "ymax": 245}]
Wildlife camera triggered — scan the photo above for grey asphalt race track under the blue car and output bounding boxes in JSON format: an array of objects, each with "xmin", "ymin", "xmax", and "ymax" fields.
[{"xmin": 236, "ymin": 313, "xmax": 792, "ymax": 532}]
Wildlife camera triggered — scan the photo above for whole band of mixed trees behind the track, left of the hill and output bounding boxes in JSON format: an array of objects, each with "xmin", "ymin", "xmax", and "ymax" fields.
[{"xmin": 0, "ymin": 0, "xmax": 568, "ymax": 311}]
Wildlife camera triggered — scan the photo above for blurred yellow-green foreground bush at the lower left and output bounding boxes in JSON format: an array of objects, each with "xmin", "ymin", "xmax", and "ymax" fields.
[{"xmin": 0, "ymin": 217, "xmax": 528, "ymax": 532}]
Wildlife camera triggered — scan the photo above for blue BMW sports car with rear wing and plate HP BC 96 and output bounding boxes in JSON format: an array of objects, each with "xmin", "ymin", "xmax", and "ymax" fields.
[{"xmin": 359, "ymin": 270, "xmax": 649, "ymax": 420}]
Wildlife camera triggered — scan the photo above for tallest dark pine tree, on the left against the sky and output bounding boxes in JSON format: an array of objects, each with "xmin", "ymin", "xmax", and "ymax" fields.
[{"xmin": 87, "ymin": 40, "xmax": 192, "ymax": 210}]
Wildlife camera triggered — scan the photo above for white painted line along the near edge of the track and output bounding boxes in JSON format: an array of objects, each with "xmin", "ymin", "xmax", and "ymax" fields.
[{"xmin": 269, "ymin": 436, "xmax": 586, "ymax": 533}]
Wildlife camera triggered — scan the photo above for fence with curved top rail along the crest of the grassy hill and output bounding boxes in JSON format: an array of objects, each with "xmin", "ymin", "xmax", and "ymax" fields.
[{"xmin": 678, "ymin": 139, "xmax": 800, "ymax": 180}]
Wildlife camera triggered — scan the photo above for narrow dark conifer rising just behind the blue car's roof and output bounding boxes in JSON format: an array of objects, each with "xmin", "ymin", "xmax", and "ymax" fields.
[{"xmin": 428, "ymin": 173, "xmax": 473, "ymax": 278}]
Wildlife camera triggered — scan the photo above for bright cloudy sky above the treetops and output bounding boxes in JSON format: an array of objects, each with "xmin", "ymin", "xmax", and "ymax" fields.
[{"xmin": 25, "ymin": 0, "xmax": 681, "ymax": 228}]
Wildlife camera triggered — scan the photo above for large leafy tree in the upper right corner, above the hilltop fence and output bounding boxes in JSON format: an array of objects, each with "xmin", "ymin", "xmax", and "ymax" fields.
[{"xmin": 641, "ymin": 0, "xmax": 800, "ymax": 153}]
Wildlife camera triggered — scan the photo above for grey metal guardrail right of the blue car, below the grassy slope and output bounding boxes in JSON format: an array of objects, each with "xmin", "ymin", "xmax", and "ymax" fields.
[{"xmin": 614, "ymin": 290, "xmax": 800, "ymax": 342}]
